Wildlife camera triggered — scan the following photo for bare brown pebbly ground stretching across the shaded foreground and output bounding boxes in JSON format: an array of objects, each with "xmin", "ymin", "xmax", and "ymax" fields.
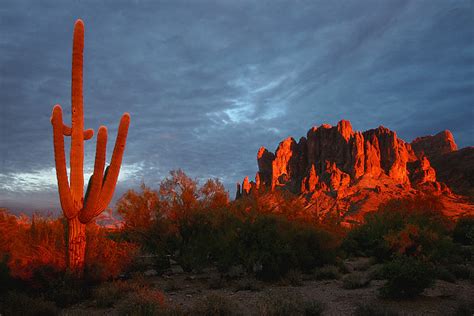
[{"xmin": 62, "ymin": 258, "xmax": 474, "ymax": 315}]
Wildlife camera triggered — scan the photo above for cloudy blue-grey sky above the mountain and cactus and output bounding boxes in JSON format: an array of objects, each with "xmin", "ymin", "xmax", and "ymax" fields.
[{"xmin": 0, "ymin": 0, "xmax": 474, "ymax": 214}]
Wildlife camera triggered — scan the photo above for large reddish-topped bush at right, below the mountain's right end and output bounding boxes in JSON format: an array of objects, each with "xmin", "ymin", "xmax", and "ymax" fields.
[{"xmin": 343, "ymin": 197, "xmax": 456, "ymax": 261}]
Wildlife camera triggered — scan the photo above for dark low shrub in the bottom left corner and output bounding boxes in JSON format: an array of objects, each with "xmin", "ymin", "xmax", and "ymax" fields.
[{"xmin": 0, "ymin": 292, "xmax": 59, "ymax": 316}]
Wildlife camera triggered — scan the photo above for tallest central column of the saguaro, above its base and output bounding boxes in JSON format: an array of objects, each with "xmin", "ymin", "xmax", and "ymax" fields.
[{"xmin": 70, "ymin": 20, "xmax": 84, "ymax": 205}]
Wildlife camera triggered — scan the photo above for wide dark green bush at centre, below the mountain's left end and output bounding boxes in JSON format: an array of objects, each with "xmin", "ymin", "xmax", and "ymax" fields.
[{"xmin": 159, "ymin": 210, "xmax": 337, "ymax": 280}]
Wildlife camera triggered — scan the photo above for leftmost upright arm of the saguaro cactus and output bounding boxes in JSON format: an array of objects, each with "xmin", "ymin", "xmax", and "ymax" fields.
[{"xmin": 51, "ymin": 105, "xmax": 77, "ymax": 219}]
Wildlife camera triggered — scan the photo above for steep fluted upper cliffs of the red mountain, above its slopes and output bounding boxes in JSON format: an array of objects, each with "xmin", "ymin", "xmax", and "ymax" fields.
[{"xmin": 243, "ymin": 120, "xmax": 442, "ymax": 193}]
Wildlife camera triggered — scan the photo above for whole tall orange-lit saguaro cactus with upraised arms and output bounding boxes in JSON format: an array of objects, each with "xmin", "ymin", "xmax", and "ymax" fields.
[{"xmin": 51, "ymin": 20, "xmax": 130, "ymax": 275}]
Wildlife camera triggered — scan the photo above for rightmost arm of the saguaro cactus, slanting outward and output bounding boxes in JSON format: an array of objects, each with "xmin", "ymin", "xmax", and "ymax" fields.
[{"xmin": 94, "ymin": 113, "xmax": 130, "ymax": 216}]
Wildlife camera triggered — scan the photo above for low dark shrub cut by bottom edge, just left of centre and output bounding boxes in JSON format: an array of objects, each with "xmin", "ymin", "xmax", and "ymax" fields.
[{"xmin": 190, "ymin": 295, "xmax": 238, "ymax": 316}]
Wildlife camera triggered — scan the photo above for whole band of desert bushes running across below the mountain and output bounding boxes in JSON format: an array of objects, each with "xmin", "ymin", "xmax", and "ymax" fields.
[{"xmin": 0, "ymin": 170, "xmax": 474, "ymax": 315}]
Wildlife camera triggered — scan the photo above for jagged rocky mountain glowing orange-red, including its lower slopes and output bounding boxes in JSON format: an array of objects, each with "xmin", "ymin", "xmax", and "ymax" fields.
[{"xmin": 236, "ymin": 120, "xmax": 474, "ymax": 220}]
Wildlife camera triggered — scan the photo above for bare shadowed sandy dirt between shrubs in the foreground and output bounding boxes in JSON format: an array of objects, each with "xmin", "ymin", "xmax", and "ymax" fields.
[{"xmin": 62, "ymin": 271, "xmax": 474, "ymax": 315}]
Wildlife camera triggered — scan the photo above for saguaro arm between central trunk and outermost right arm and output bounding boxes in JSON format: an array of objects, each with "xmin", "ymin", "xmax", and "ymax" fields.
[{"xmin": 79, "ymin": 126, "xmax": 107, "ymax": 224}]
